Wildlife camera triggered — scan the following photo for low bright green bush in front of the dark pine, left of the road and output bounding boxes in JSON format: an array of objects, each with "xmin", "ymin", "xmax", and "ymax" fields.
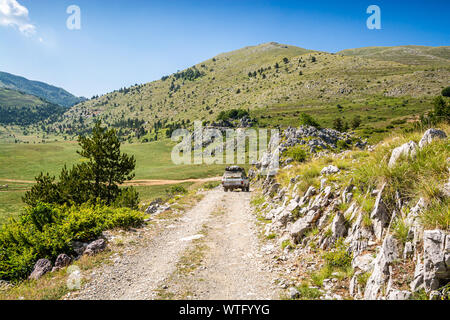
[{"xmin": 0, "ymin": 203, "xmax": 144, "ymax": 281}]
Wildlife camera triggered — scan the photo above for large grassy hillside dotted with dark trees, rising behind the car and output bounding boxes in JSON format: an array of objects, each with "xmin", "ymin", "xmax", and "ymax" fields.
[{"xmin": 44, "ymin": 43, "xmax": 450, "ymax": 140}]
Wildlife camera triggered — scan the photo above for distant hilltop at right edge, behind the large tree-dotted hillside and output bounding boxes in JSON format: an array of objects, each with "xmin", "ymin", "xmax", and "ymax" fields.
[{"xmin": 338, "ymin": 46, "xmax": 450, "ymax": 66}]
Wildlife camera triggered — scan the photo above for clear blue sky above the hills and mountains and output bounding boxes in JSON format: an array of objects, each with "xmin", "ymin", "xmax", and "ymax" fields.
[{"xmin": 0, "ymin": 0, "xmax": 450, "ymax": 97}]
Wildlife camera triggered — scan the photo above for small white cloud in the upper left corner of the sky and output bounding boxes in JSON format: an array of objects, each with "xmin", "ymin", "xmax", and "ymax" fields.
[{"xmin": 0, "ymin": 0, "xmax": 36, "ymax": 36}]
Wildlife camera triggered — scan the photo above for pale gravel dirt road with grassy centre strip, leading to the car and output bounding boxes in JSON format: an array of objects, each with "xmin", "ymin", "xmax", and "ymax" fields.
[{"xmin": 71, "ymin": 189, "xmax": 278, "ymax": 300}]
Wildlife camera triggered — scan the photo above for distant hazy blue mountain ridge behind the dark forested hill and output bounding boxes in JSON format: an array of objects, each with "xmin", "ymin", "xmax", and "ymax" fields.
[{"xmin": 0, "ymin": 72, "xmax": 85, "ymax": 107}]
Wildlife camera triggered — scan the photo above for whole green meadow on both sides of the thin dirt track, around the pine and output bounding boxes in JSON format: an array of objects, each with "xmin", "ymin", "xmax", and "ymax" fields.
[{"xmin": 0, "ymin": 140, "xmax": 229, "ymax": 224}]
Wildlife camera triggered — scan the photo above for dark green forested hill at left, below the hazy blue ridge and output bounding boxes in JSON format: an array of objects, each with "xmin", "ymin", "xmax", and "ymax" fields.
[{"xmin": 0, "ymin": 88, "xmax": 66, "ymax": 126}]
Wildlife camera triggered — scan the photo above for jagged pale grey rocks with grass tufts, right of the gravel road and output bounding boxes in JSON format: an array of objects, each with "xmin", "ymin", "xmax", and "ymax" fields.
[{"xmin": 251, "ymin": 129, "xmax": 450, "ymax": 300}]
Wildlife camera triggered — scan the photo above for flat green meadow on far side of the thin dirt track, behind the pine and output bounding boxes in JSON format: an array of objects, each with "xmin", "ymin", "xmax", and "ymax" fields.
[{"xmin": 0, "ymin": 140, "xmax": 224, "ymax": 181}]
